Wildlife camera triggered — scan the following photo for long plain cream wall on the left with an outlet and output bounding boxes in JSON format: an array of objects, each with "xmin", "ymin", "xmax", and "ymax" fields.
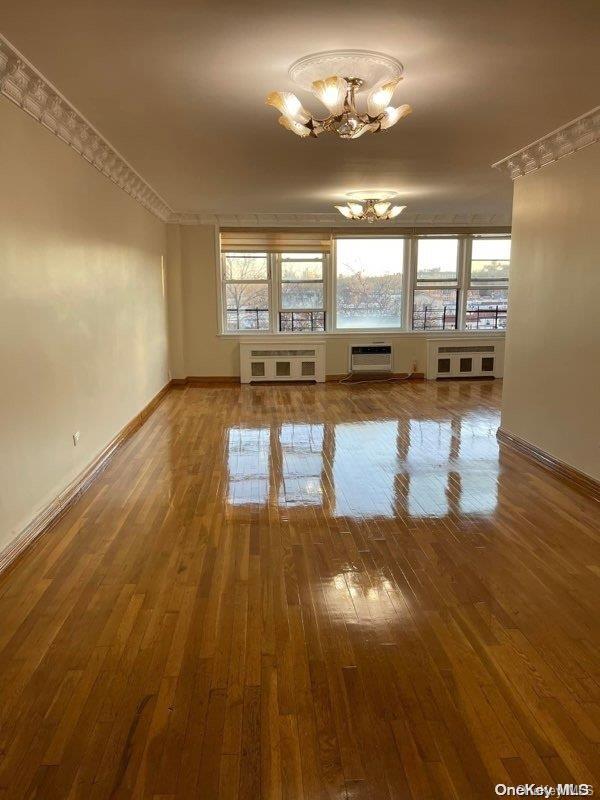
[{"xmin": 0, "ymin": 98, "xmax": 168, "ymax": 550}]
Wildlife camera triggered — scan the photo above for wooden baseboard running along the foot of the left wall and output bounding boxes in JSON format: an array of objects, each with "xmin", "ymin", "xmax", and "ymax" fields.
[{"xmin": 0, "ymin": 382, "xmax": 171, "ymax": 574}]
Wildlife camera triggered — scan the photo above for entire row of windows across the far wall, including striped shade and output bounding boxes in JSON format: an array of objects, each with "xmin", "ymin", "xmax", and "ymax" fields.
[{"xmin": 221, "ymin": 229, "xmax": 510, "ymax": 335}]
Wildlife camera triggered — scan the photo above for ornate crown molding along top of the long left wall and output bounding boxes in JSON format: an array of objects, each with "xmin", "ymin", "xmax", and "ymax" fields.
[{"xmin": 0, "ymin": 35, "xmax": 173, "ymax": 221}]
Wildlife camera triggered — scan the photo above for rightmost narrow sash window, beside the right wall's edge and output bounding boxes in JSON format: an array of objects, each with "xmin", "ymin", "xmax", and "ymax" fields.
[{"xmin": 465, "ymin": 236, "xmax": 510, "ymax": 330}]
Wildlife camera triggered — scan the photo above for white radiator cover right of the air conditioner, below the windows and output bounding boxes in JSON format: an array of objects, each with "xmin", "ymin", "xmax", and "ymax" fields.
[{"xmin": 427, "ymin": 337, "xmax": 504, "ymax": 380}]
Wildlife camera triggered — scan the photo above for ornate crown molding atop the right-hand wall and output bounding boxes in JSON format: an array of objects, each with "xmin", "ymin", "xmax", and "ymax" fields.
[{"xmin": 492, "ymin": 106, "xmax": 600, "ymax": 180}]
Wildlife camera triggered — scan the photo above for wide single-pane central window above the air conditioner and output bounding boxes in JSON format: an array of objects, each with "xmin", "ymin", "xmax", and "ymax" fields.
[{"xmin": 336, "ymin": 238, "xmax": 404, "ymax": 330}]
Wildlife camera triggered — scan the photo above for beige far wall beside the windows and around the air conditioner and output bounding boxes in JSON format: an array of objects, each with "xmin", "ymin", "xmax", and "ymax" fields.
[{"xmin": 168, "ymin": 225, "xmax": 502, "ymax": 378}]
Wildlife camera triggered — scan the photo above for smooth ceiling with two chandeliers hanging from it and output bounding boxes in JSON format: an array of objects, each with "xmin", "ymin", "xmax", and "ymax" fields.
[{"xmin": 0, "ymin": 0, "xmax": 600, "ymax": 224}]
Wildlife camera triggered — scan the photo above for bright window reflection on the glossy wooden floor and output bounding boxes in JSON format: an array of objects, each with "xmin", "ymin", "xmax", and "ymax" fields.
[{"xmin": 226, "ymin": 387, "xmax": 499, "ymax": 519}]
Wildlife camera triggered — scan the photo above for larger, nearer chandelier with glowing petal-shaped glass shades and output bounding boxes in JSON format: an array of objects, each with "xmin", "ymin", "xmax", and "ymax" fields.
[{"xmin": 266, "ymin": 75, "xmax": 412, "ymax": 139}]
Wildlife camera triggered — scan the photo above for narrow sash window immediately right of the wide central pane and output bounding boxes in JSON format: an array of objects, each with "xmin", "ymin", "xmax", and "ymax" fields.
[{"xmin": 413, "ymin": 237, "xmax": 459, "ymax": 331}]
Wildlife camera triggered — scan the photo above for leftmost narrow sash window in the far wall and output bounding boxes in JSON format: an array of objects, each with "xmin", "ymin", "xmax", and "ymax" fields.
[{"xmin": 223, "ymin": 253, "xmax": 270, "ymax": 331}]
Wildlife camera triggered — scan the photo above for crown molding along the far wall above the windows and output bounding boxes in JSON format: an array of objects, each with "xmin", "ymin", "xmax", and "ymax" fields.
[{"xmin": 167, "ymin": 211, "xmax": 510, "ymax": 231}]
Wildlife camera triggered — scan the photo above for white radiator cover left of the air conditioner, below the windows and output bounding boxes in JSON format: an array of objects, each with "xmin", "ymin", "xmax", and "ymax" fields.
[{"xmin": 240, "ymin": 337, "xmax": 325, "ymax": 383}]
